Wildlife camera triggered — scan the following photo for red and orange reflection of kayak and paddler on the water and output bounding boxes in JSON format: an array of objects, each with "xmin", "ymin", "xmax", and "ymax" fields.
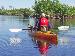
[{"xmin": 32, "ymin": 31, "xmax": 58, "ymax": 56}]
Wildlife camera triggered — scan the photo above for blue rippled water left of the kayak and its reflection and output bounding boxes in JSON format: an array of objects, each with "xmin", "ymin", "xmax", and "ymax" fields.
[{"xmin": 0, "ymin": 16, "xmax": 39, "ymax": 56}]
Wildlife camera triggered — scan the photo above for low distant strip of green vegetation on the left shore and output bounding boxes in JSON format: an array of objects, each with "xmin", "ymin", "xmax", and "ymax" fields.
[{"xmin": 0, "ymin": 8, "xmax": 32, "ymax": 17}]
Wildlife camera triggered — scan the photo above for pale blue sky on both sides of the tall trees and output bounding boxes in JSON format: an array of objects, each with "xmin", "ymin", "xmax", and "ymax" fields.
[{"xmin": 0, "ymin": 0, "xmax": 75, "ymax": 9}]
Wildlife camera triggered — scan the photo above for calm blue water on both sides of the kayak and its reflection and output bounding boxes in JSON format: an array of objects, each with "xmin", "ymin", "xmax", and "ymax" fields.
[{"xmin": 0, "ymin": 16, "xmax": 75, "ymax": 56}]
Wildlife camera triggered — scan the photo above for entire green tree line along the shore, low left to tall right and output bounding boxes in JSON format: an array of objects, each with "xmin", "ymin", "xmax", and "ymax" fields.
[{"xmin": 0, "ymin": 0, "xmax": 75, "ymax": 20}]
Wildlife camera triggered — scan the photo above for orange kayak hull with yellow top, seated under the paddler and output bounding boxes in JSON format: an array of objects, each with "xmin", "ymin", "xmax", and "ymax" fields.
[{"xmin": 28, "ymin": 31, "xmax": 57, "ymax": 41}]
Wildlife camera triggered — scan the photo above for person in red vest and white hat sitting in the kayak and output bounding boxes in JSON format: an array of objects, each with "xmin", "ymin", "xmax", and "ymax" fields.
[{"xmin": 36, "ymin": 13, "xmax": 49, "ymax": 31}]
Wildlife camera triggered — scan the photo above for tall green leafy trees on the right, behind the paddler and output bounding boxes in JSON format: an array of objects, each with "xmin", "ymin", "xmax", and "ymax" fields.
[{"xmin": 33, "ymin": 0, "xmax": 75, "ymax": 15}]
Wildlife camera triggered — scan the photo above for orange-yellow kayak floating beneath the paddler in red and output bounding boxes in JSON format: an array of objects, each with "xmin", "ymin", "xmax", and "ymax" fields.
[{"xmin": 29, "ymin": 31, "xmax": 58, "ymax": 45}]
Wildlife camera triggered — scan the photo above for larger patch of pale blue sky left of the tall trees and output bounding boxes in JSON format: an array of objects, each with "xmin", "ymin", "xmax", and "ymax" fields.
[{"xmin": 0, "ymin": 0, "xmax": 34, "ymax": 9}]
